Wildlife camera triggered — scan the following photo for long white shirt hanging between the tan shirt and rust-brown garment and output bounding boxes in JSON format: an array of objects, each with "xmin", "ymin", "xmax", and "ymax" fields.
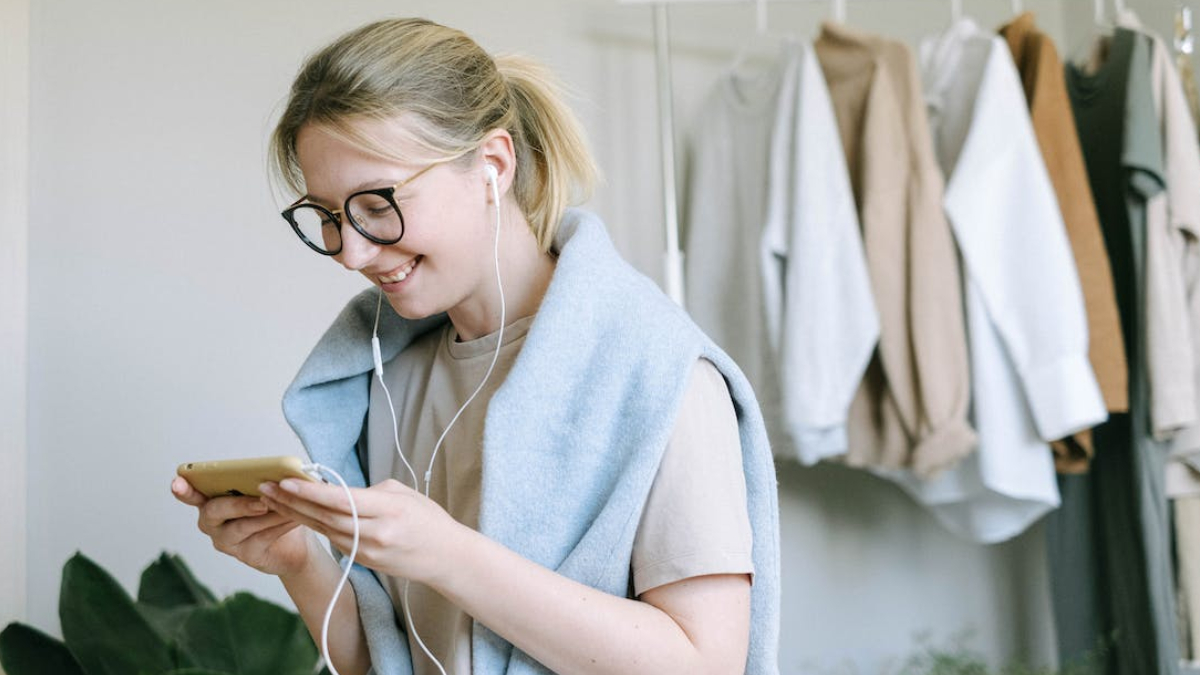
[{"xmin": 868, "ymin": 19, "xmax": 1108, "ymax": 543}]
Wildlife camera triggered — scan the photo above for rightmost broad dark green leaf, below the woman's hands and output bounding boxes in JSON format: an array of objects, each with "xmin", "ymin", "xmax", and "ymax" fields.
[{"xmin": 179, "ymin": 593, "xmax": 317, "ymax": 675}]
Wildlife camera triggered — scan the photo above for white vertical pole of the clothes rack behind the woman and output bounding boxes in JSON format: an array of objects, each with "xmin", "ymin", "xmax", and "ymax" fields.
[{"xmin": 654, "ymin": 2, "xmax": 683, "ymax": 305}]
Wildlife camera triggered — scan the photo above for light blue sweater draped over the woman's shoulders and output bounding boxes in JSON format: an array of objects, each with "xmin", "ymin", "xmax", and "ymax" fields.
[{"xmin": 283, "ymin": 210, "xmax": 779, "ymax": 675}]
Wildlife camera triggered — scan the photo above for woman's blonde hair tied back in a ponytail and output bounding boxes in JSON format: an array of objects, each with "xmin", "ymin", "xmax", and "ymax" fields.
[{"xmin": 270, "ymin": 19, "xmax": 596, "ymax": 251}]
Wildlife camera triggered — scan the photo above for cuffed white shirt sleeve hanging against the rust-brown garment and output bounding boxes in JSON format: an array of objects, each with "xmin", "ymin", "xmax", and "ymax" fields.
[{"xmin": 947, "ymin": 40, "xmax": 1108, "ymax": 441}]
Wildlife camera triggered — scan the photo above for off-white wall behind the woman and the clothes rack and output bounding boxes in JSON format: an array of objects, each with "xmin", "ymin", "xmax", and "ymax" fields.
[{"xmin": 21, "ymin": 0, "xmax": 1062, "ymax": 674}]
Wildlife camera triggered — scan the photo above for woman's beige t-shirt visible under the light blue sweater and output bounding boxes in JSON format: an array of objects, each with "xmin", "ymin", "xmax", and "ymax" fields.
[{"xmin": 367, "ymin": 317, "xmax": 754, "ymax": 675}]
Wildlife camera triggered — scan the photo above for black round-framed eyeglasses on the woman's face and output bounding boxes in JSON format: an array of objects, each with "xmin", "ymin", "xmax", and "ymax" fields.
[{"xmin": 280, "ymin": 162, "xmax": 442, "ymax": 256}]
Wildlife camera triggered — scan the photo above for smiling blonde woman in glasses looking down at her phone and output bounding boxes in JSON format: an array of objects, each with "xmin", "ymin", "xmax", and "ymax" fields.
[{"xmin": 172, "ymin": 19, "xmax": 779, "ymax": 675}]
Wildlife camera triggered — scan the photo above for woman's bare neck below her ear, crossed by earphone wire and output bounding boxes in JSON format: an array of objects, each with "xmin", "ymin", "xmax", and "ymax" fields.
[{"xmin": 448, "ymin": 207, "xmax": 554, "ymax": 340}]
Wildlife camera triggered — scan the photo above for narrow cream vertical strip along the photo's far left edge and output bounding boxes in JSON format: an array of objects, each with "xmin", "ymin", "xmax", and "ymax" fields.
[{"xmin": 0, "ymin": 0, "xmax": 29, "ymax": 638}]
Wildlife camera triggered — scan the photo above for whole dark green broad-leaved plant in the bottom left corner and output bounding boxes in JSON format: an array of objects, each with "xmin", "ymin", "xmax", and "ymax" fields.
[{"xmin": 0, "ymin": 552, "xmax": 318, "ymax": 675}]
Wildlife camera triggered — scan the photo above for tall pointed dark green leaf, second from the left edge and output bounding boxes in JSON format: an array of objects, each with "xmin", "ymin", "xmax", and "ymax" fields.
[{"xmin": 59, "ymin": 552, "xmax": 176, "ymax": 675}]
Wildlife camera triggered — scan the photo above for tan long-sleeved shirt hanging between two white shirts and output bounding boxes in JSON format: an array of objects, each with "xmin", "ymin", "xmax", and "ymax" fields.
[{"xmin": 815, "ymin": 23, "xmax": 976, "ymax": 477}]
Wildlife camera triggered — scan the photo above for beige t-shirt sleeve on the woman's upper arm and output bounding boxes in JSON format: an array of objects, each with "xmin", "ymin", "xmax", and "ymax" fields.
[{"xmin": 631, "ymin": 359, "xmax": 754, "ymax": 596}]
